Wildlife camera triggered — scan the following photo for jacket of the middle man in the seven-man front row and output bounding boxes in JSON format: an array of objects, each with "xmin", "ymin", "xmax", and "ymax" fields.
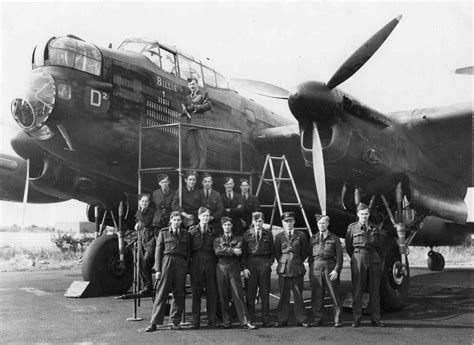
[{"xmin": 242, "ymin": 228, "xmax": 275, "ymax": 269}]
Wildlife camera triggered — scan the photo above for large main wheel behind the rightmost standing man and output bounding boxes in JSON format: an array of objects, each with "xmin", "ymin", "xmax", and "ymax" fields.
[{"xmin": 380, "ymin": 245, "xmax": 410, "ymax": 311}]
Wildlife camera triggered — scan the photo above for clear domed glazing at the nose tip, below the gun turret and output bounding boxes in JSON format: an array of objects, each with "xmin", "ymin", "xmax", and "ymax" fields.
[{"xmin": 11, "ymin": 72, "xmax": 56, "ymax": 132}]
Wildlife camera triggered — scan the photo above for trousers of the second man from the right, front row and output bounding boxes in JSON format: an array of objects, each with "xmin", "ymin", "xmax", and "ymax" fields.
[{"xmin": 309, "ymin": 260, "xmax": 341, "ymax": 323}]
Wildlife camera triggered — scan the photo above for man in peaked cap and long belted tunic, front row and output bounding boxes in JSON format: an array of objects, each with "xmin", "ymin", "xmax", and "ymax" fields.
[{"xmin": 275, "ymin": 212, "xmax": 309, "ymax": 327}]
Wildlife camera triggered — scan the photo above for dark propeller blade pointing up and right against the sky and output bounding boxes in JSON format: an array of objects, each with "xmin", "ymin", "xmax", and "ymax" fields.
[{"xmin": 327, "ymin": 15, "xmax": 402, "ymax": 89}]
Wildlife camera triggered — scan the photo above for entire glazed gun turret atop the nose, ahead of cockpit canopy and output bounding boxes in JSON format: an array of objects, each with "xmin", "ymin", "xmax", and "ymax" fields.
[{"xmin": 32, "ymin": 36, "xmax": 102, "ymax": 76}]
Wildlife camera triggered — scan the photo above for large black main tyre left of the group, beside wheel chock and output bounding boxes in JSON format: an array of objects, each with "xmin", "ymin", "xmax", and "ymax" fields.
[{"xmin": 82, "ymin": 235, "xmax": 133, "ymax": 295}]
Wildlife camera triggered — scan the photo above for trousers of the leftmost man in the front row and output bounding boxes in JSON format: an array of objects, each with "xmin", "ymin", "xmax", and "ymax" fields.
[{"xmin": 150, "ymin": 255, "xmax": 188, "ymax": 325}]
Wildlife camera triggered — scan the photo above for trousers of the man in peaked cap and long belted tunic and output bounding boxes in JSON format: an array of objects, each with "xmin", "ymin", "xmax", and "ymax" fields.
[{"xmin": 277, "ymin": 275, "xmax": 306, "ymax": 322}]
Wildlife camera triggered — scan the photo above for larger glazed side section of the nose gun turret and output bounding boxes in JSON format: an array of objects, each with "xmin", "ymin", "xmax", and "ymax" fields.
[{"xmin": 44, "ymin": 37, "xmax": 102, "ymax": 75}]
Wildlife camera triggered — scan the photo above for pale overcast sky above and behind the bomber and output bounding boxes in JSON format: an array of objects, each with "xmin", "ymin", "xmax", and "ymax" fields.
[{"xmin": 0, "ymin": 0, "xmax": 473, "ymax": 225}]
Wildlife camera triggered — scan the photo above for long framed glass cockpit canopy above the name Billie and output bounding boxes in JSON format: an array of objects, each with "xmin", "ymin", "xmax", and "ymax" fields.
[{"xmin": 118, "ymin": 38, "xmax": 229, "ymax": 89}]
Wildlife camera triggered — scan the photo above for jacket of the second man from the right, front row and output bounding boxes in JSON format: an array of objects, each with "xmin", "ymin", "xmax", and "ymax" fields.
[{"xmin": 308, "ymin": 231, "xmax": 343, "ymax": 273}]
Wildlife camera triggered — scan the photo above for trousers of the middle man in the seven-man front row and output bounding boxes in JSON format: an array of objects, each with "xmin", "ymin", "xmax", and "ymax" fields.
[{"xmin": 247, "ymin": 256, "xmax": 271, "ymax": 323}]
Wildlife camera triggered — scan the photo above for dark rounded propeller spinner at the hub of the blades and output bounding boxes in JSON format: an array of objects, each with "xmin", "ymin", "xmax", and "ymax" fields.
[{"xmin": 288, "ymin": 81, "xmax": 337, "ymax": 122}]
